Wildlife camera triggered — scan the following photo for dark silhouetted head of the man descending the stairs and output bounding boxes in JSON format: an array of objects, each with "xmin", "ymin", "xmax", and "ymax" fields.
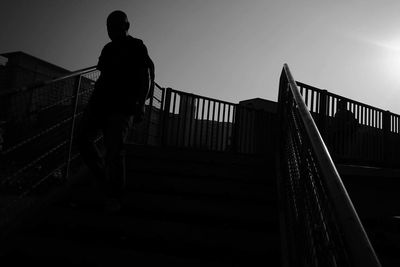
[{"xmin": 107, "ymin": 10, "xmax": 129, "ymax": 41}]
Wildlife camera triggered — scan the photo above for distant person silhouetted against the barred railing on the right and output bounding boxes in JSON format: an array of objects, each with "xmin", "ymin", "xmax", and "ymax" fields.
[{"xmin": 335, "ymin": 99, "xmax": 358, "ymax": 156}]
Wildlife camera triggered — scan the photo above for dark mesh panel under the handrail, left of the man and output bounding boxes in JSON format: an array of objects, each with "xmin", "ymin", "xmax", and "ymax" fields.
[{"xmin": 0, "ymin": 71, "xmax": 99, "ymax": 199}]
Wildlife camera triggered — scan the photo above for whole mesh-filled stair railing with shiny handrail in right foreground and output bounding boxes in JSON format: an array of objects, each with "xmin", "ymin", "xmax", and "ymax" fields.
[{"xmin": 278, "ymin": 65, "xmax": 380, "ymax": 267}]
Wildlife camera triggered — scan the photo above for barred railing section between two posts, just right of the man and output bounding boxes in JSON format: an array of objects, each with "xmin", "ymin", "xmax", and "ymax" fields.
[{"xmin": 164, "ymin": 88, "xmax": 236, "ymax": 151}]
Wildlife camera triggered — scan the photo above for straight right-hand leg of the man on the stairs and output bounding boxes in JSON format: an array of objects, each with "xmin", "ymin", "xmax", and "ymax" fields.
[{"xmin": 103, "ymin": 113, "xmax": 131, "ymax": 198}]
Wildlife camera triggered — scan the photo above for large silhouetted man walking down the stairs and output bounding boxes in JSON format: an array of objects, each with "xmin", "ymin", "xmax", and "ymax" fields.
[{"xmin": 78, "ymin": 11, "xmax": 154, "ymax": 213}]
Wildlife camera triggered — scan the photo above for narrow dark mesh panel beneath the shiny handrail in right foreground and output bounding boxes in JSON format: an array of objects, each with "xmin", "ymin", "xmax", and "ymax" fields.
[{"xmin": 283, "ymin": 89, "xmax": 350, "ymax": 266}]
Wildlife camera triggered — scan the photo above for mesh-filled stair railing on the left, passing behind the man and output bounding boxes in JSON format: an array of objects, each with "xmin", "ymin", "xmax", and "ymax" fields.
[{"xmin": 0, "ymin": 67, "xmax": 164, "ymax": 224}]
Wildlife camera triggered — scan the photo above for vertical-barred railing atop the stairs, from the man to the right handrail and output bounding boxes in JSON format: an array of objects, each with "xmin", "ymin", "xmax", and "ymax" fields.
[{"xmin": 158, "ymin": 88, "xmax": 275, "ymax": 154}]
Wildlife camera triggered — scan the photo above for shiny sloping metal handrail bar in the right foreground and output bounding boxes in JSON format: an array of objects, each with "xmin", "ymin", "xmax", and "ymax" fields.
[{"xmin": 282, "ymin": 64, "xmax": 381, "ymax": 267}]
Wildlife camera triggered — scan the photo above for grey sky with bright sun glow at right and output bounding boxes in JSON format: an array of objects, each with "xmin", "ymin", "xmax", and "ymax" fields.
[{"xmin": 0, "ymin": 0, "xmax": 400, "ymax": 113}]
